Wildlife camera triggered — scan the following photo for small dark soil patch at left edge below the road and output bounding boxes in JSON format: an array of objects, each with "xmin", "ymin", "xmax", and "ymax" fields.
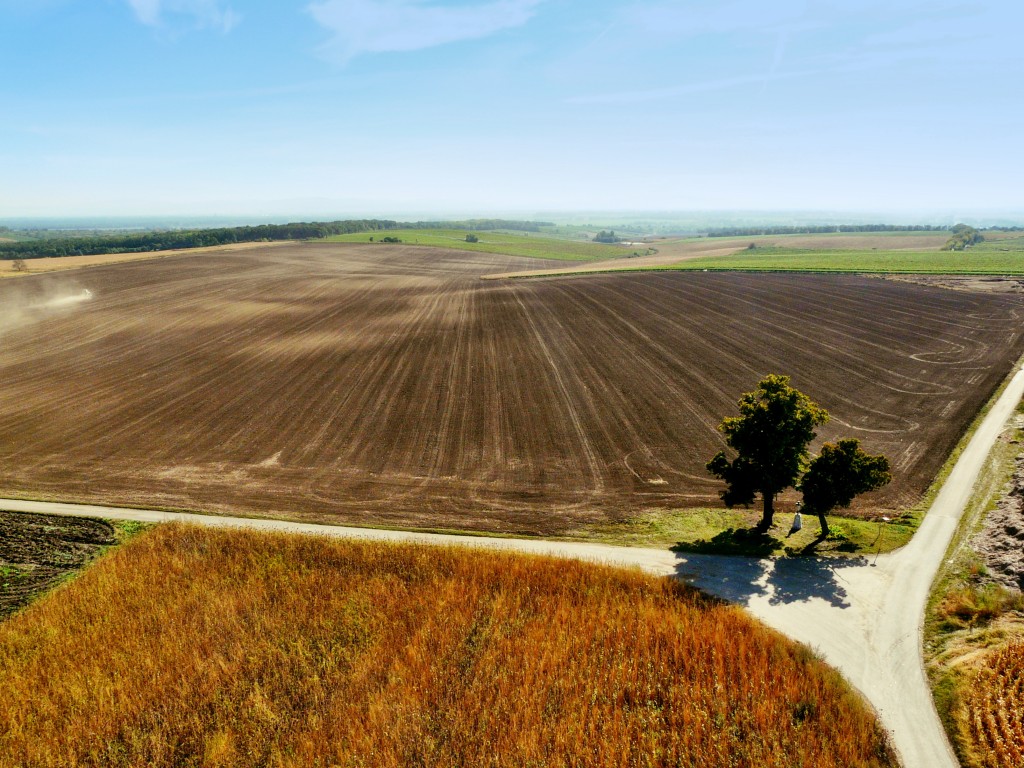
[{"xmin": 0, "ymin": 512, "xmax": 117, "ymax": 620}]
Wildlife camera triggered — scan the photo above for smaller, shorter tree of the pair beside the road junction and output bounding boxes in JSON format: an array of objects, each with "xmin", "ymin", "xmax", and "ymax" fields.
[{"xmin": 800, "ymin": 437, "xmax": 893, "ymax": 539}]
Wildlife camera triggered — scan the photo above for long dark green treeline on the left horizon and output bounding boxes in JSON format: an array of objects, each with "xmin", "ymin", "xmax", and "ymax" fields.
[{"xmin": 0, "ymin": 219, "xmax": 549, "ymax": 259}]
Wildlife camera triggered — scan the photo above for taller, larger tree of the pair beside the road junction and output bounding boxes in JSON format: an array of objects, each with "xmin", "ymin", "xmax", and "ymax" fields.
[{"xmin": 707, "ymin": 374, "xmax": 828, "ymax": 530}]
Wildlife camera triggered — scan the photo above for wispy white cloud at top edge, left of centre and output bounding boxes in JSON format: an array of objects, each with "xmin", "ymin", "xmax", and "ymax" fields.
[{"xmin": 308, "ymin": 0, "xmax": 543, "ymax": 62}]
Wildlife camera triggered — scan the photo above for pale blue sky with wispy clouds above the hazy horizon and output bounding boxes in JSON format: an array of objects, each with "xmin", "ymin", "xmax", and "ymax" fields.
[{"xmin": 0, "ymin": 0, "xmax": 1024, "ymax": 218}]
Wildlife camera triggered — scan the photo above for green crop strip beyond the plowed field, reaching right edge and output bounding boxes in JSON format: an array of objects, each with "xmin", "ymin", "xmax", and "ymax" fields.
[{"xmin": 670, "ymin": 246, "xmax": 1024, "ymax": 274}]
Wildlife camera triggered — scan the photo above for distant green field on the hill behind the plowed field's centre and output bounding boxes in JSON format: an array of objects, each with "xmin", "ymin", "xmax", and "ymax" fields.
[{"xmin": 328, "ymin": 229, "xmax": 627, "ymax": 261}]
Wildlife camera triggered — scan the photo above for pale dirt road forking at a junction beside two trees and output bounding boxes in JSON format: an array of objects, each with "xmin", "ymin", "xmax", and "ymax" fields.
[{"xmin": 0, "ymin": 371, "xmax": 1024, "ymax": 768}]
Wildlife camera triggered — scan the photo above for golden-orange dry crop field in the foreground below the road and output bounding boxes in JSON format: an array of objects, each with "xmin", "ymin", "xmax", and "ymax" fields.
[{"xmin": 0, "ymin": 525, "xmax": 895, "ymax": 768}]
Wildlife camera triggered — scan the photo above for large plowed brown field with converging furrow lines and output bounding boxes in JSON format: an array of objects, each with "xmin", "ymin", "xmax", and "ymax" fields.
[{"xmin": 0, "ymin": 245, "xmax": 1024, "ymax": 534}]
